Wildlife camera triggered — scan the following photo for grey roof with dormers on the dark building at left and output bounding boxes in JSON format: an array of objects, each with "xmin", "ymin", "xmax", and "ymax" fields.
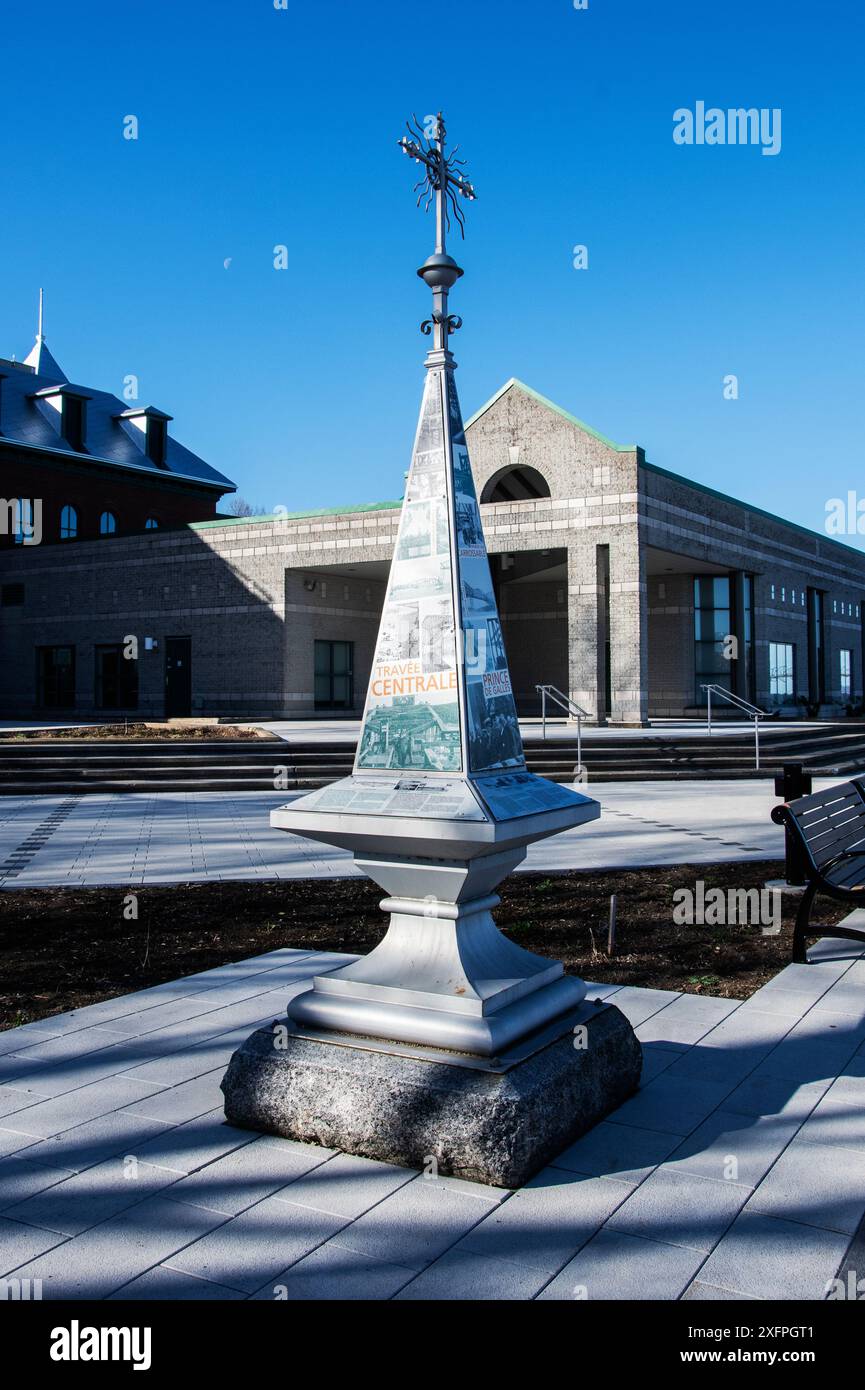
[{"xmin": 0, "ymin": 338, "xmax": 235, "ymax": 492}]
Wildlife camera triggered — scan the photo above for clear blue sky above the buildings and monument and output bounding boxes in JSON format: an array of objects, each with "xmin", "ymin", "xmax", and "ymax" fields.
[{"xmin": 0, "ymin": 0, "xmax": 865, "ymax": 545}]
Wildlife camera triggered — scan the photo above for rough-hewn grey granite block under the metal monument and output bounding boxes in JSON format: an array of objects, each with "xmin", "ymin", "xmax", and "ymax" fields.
[{"xmin": 223, "ymin": 1005, "xmax": 641, "ymax": 1187}]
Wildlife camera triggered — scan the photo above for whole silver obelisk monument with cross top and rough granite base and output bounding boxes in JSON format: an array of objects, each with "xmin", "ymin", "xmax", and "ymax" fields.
[{"xmin": 223, "ymin": 114, "xmax": 640, "ymax": 1186}]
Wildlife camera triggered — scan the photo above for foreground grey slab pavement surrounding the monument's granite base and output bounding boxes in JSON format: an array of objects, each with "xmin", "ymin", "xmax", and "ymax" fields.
[{"xmin": 0, "ymin": 913, "xmax": 865, "ymax": 1300}]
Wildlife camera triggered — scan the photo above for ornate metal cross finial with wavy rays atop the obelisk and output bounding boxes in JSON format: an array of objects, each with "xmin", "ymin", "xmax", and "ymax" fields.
[{"xmin": 398, "ymin": 111, "xmax": 477, "ymax": 353}]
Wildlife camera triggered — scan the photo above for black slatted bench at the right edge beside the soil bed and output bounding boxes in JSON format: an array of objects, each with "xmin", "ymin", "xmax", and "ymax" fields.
[{"xmin": 772, "ymin": 778, "xmax": 865, "ymax": 965}]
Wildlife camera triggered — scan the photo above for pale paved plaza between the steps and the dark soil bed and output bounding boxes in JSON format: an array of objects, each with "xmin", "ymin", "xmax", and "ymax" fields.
[{"xmin": 0, "ymin": 778, "xmax": 839, "ymax": 888}]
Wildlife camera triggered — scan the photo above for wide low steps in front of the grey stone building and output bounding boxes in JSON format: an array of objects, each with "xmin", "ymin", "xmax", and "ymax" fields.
[{"xmin": 0, "ymin": 721, "xmax": 865, "ymax": 795}]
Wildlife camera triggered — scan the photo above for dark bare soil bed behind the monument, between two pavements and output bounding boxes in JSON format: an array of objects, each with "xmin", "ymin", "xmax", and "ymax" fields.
[{"xmin": 0, "ymin": 860, "xmax": 846, "ymax": 1029}]
